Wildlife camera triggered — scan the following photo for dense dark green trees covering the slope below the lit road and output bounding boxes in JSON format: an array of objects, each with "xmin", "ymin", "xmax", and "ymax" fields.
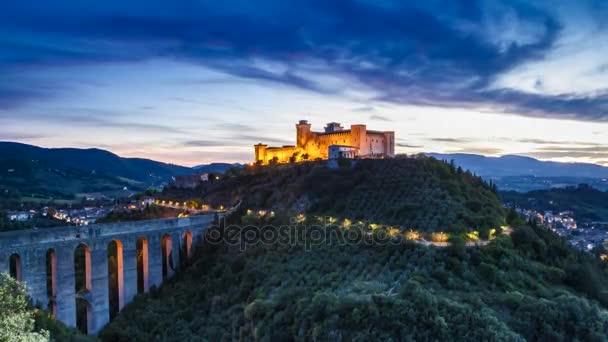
[{"xmin": 100, "ymin": 215, "xmax": 608, "ymax": 341}]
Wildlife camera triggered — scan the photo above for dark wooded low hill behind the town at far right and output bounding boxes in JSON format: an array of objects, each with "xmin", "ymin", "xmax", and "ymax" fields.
[{"xmin": 500, "ymin": 184, "xmax": 608, "ymax": 222}]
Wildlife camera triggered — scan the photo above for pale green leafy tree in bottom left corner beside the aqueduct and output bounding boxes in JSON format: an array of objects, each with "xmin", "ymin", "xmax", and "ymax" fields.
[{"xmin": 0, "ymin": 273, "xmax": 50, "ymax": 342}]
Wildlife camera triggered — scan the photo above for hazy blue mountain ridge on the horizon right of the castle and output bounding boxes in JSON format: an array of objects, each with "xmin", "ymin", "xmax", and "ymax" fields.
[{"xmin": 427, "ymin": 153, "xmax": 608, "ymax": 178}]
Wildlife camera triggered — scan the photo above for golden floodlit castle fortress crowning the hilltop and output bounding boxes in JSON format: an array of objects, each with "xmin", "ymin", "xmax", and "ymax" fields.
[{"xmin": 254, "ymin": 120, "xmax": 395, "ymax": 164}]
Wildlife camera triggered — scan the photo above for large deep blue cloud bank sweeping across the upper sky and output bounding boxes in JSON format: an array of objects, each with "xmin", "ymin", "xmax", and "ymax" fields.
[{"xmin": 0, "ymin": 0, "xmax": 608, "ymax": 121}]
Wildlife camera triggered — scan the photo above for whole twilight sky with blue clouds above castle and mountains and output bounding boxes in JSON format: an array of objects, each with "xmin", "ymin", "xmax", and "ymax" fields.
[{"xmin": 0, "ymin": 0, "xmax": 608, "ymax": 166}]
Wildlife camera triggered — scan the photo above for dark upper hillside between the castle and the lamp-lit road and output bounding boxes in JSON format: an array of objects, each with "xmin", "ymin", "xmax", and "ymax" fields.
[{"xmin": 157, "ymin": 156, "xmax": 504, "ymax": 231}]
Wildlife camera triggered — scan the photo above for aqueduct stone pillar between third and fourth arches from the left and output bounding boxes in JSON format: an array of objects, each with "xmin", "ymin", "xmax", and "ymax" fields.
[{"xmin": 89, "ymin": 241, "xmax": 110, "ymax": 334}]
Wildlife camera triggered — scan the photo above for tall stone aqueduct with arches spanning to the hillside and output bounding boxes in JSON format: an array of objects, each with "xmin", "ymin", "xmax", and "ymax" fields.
[{"xmin": 0, "ymin": 215, "xmax": 214, "ymax": 334}]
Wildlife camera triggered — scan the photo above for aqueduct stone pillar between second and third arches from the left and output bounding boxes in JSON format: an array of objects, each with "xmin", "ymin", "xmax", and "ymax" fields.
[{"xmin": 55, "ymin": 244, "xmax": 76, "ymax": 327}]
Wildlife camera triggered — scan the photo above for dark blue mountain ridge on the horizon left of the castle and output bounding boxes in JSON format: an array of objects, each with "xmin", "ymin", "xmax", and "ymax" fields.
[{"xmin": 0, "ymin": 142, "xmax": 192, "ymax": 184}]
